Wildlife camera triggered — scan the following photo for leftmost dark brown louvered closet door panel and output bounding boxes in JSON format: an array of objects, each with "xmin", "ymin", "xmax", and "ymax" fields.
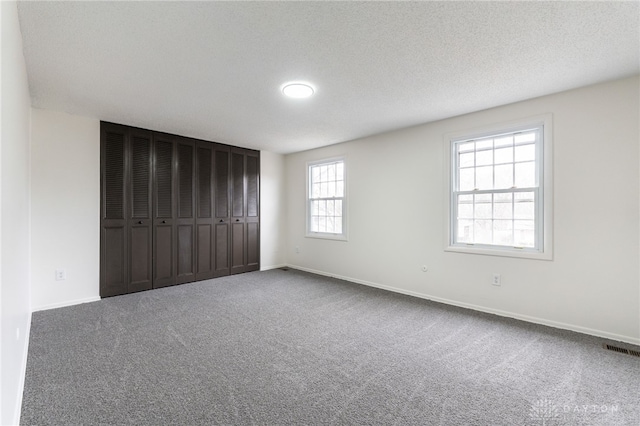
[{"xmin": 100, "ymin": 123, "xmax": 129, "ymax": 297}]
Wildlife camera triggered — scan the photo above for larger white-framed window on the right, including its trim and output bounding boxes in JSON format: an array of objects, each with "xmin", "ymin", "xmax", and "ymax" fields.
[{"xmin": 446, "ymin": 116, "xmax": 552, "ymax": 259}]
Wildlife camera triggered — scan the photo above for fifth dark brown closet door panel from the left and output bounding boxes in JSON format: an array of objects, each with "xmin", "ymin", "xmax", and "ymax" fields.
[{"xmin": 195, "ymin": 142, "xmax": 215, "ymax": 281}]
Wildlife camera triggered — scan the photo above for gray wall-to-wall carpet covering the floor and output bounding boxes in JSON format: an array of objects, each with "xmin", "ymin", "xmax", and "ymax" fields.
[{"xmin": 21, "ymin": 270, "xmax": 640, "ymax": 426}]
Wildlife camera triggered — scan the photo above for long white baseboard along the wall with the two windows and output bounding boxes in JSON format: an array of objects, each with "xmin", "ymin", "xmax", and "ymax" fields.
[{"xmin": 287, "ymin": 265, "xmax": 640, "ymax": 345}]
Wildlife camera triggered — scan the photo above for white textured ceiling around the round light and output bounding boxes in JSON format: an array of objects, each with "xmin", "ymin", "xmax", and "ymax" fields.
[{"xmin": 18, "ymin": 1, "xmax": 640, "ymax": 153}]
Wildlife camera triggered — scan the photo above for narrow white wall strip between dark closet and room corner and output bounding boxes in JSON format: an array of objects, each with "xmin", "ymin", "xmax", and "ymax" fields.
[{"xmin": 260, "ymin": 151, "xmax": 286, "ymax": 271}]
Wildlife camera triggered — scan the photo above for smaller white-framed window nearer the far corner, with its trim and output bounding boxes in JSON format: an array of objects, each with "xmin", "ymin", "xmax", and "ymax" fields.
[{"xmin": 307, "ymin": 158, "xmax": 347, "ymax": 240}]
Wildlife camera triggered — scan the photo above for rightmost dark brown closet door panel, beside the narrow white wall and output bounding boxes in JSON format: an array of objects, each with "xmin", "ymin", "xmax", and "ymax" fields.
[{"xmin": 245, "ymin": 152, "xmax": 260, "ymax": 272}]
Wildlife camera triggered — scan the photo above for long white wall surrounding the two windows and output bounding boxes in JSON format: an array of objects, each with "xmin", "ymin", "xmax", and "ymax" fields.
[{"xmin": 285, "ymin": 77, "xmax": 640, "ymax": 343}]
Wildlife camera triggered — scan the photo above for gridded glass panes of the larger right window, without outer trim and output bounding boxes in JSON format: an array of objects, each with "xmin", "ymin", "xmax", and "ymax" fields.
[{"xmin": 452, "ymin": 128, "xmax": 541, "ymax": 248}]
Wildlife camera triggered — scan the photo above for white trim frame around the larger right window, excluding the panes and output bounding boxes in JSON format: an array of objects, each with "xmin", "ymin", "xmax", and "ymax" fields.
[{"xmin": 443, "ymin": 114, "xmax": 553, "ymax": 260}]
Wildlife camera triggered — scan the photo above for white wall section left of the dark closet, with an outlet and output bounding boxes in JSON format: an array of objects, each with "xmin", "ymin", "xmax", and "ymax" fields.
[{"xmin": 31, "ymin": 108, "xmax": 100, "ymax": 310}]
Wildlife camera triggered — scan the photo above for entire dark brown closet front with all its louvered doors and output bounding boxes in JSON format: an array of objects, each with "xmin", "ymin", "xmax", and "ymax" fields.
[{"xmin": 100, "ymin": 122, "xmax": 260, "ymax": 297}]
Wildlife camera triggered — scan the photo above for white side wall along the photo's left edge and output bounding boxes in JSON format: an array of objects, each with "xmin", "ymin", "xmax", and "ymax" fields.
[{"xmin": 0, "ymin": 2, "xmax": 31, "ymax": 425}]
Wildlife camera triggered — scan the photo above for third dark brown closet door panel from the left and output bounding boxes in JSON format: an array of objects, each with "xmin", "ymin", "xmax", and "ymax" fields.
[{"xmin": 153, "ymin": 134, "xmax": 176, "ymax": 288}]
